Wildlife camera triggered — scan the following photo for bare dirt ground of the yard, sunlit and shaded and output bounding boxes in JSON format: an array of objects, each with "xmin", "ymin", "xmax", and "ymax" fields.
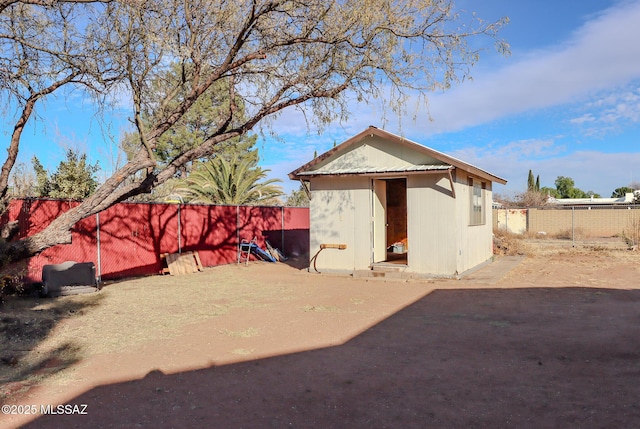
[{"xmin": 0, "ymin": 242, "xmax": 640, "ymax": 428}]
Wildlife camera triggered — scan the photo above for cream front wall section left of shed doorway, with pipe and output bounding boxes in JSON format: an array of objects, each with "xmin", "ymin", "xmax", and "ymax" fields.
[{"xmin": 309, "ymin": 177, "xmax": 371, "ymax": 271}]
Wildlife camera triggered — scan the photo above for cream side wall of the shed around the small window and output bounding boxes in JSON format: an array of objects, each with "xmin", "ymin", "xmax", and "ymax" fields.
[{"xmin": 456, "ymin": 172, "xmax": 493, "ymax": 274}]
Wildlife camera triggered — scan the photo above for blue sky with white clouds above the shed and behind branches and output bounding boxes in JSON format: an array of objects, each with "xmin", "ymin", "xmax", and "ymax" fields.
[{"xmin": 1, "ymin": 0, "xmax": 640, "ymax": 197}]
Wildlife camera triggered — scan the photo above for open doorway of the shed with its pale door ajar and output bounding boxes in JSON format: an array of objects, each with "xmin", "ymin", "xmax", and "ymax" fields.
[{"xmin": 373, "ymin": 178, "xmax": 409, "ymax": 265}]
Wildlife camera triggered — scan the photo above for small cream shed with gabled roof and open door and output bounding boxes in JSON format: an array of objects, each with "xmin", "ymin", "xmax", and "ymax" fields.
[{"xmin": 289, "ymin": 126, "xmax": 507, "ymax": 277}]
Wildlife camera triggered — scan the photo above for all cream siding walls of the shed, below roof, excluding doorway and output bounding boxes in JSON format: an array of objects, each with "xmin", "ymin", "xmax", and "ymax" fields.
[{"xmin": 310, "ymin": 167, "xmax": 493, "ymax": 276}]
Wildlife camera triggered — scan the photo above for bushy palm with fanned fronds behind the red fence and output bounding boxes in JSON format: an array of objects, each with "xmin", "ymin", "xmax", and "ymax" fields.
[{"xmin": 178, "ymin": 156, "xmax": 283, "ymax": 205}]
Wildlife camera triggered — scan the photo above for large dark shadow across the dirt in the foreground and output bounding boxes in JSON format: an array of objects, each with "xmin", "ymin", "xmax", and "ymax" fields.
[{"xmin": 27, "ymin": 288, "xmax": 640, "ymax": 428}]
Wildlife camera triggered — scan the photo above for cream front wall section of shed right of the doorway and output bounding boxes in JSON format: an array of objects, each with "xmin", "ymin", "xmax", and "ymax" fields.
[{"xmin": 407, "ymin": 175, "xmax": 457, "ymax": 276}]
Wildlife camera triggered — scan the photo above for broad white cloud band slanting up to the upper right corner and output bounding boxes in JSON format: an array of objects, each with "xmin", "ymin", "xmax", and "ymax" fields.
[{"xmin": 404, "ymin": 2, "xmax": 640, "ymax": 134}]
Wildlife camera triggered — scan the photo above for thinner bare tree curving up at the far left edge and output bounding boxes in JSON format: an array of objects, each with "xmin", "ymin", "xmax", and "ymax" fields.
[{"xmin": 0, "ymin": 1, "xmax": 121, "ymax": 205}]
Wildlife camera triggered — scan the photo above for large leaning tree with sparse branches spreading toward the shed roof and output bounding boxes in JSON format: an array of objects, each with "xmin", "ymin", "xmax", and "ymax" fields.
[{"xmin": 0, "ymin": 0, "xmax": 507, "ymax": 266}]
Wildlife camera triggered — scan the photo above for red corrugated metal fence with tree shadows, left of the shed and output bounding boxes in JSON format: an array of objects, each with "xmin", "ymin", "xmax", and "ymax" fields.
[{"xmin": 3, "ymin": 199, "xmax": 309, "ymax": 282}]
